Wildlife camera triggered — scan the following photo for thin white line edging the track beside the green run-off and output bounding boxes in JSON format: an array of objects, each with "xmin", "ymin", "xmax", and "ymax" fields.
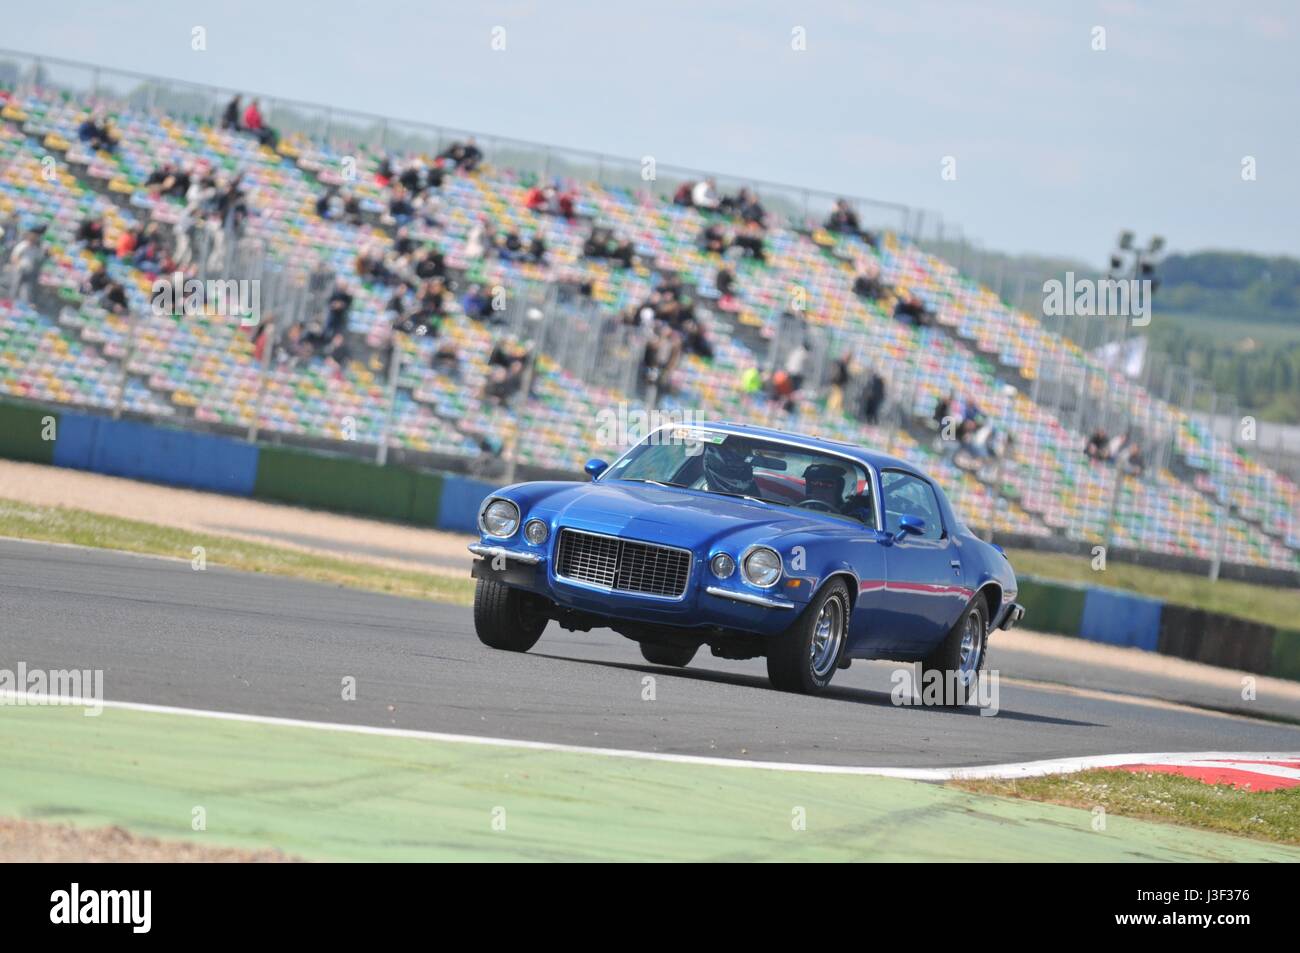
[{"xmin": 10, "ymin": 689, "xmax": 1300, "ymax": 781}]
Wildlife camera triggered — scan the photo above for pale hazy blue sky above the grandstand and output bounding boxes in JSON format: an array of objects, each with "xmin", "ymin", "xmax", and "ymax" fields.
[{"xmin": 0, "ymin": 0, "xmax": 1300, "ymax": 265}]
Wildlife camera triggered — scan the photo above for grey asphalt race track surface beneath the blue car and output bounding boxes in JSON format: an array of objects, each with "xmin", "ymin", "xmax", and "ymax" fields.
[{"xmin": 0, "ymin": 541, "xmax": 1300, "ymax": 767}]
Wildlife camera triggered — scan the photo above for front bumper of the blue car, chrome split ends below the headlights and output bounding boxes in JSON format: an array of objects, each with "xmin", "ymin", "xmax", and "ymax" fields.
[{"xmin": 469, "ymin": 542, "xmax": 805, "ymax": 634}]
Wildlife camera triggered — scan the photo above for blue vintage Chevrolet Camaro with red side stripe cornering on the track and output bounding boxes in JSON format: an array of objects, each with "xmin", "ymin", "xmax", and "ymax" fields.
[{"xmin": 469, "ymin": 424, "xmax": 1024, "ymax": 703}]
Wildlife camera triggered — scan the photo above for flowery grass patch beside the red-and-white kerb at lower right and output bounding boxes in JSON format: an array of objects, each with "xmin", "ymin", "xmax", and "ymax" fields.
[{"xmin": 950, "ymin": 770, "xmax": 1300, "ymax": 846}]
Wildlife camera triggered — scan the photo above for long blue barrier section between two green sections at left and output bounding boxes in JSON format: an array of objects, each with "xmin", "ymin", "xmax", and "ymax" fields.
[{"xmin": 53, "ymin": 413, "xmax": 257, "ymax": 497}]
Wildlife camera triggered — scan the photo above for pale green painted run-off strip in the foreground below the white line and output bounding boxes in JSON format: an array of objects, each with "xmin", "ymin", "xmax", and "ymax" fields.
[{"xmin": 0, "ymin": 698, "xmax": 1300, "ymax": 863}]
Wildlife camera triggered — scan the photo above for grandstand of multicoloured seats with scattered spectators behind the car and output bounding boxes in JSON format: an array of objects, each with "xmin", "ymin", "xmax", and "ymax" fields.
[{"xmin": 0, "ymin": 61, "xmax": 1300, "ymax": 571}]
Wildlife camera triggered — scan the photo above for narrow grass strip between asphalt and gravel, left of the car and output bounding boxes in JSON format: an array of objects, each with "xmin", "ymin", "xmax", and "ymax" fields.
[{"xmin": 0, "ymin": 499, "xmax": 473, "ymax": 606}]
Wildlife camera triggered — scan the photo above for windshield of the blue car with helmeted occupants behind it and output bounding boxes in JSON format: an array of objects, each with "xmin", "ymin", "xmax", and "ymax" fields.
[{"xmin": 602, "ymin": 428, "xmax": 875, "ymax": 528}]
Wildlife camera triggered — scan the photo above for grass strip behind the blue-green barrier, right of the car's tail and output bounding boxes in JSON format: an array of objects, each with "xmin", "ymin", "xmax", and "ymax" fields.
[{"xmin": 1006, "ymin": 549, "xmax": 1300, "ymax": 628}]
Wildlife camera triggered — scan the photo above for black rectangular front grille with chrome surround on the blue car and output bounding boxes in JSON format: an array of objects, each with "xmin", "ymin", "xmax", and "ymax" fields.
[{"xmin": 555, "ymin": 529, "xmax": 690, "ymax": 598}]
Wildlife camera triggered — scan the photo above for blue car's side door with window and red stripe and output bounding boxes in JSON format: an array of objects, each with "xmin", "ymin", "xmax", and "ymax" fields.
[{"xmin": 880, "ymin": 469, "xmax": 965, "ymax": 651}]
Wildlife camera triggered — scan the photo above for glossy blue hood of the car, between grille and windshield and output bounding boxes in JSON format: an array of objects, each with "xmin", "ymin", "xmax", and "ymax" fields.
[{"xmin": 506, "ymin": 482, "xmax": 862, "ymax": 547}]
